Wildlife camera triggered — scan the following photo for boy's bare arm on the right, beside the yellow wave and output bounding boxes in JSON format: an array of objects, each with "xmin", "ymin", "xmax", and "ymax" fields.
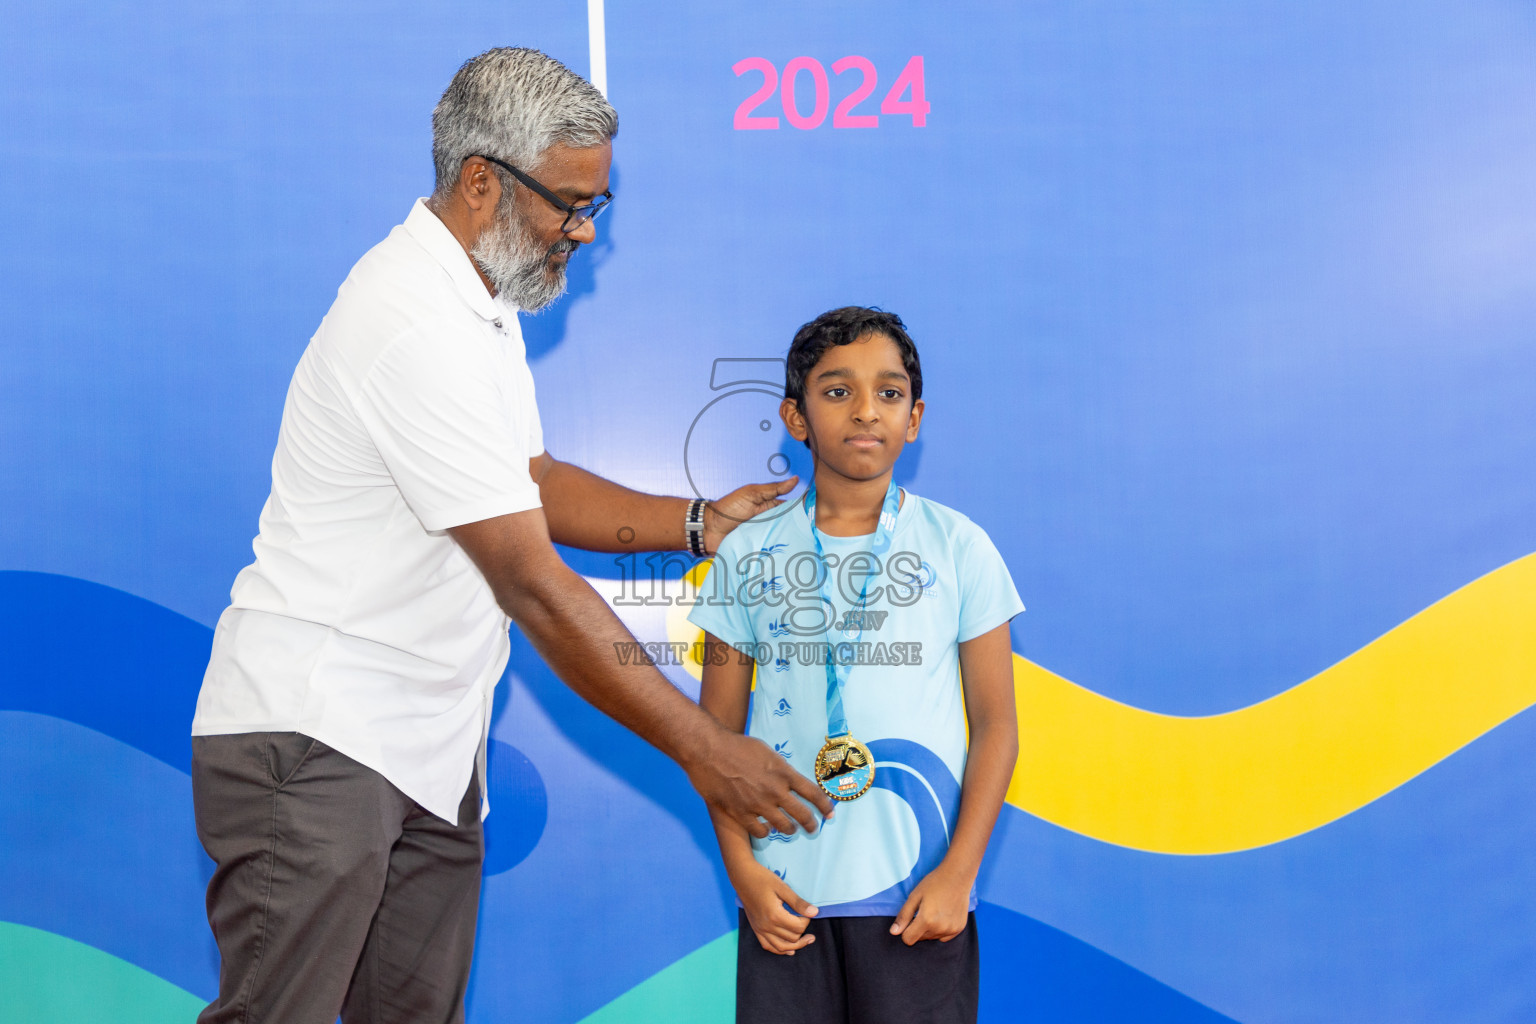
[{"xmin": 891, "ymin": 622, "xmax": 1018, "ymax": 946}]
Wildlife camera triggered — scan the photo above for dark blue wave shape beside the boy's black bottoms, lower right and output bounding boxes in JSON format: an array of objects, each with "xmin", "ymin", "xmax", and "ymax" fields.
[{"xmin": 975, "ymin": 901, "xmax": 1233, "ymax": 1024}]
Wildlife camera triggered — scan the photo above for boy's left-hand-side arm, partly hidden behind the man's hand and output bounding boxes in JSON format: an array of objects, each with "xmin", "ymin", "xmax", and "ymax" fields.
[{"xmin": 699, "ymin": 633, "xmax": 816, "ymax": 956}]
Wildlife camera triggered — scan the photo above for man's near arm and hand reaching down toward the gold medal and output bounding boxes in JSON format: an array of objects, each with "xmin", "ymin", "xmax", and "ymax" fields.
[{"xmin": 449, "ymin": 508, "xmax": 833, "ymax": 837}]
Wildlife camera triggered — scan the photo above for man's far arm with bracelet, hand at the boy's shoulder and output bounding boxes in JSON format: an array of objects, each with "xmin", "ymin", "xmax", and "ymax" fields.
[{"xmin": 528, "ymin": 451, "xmax": 799, "ymax": 553}]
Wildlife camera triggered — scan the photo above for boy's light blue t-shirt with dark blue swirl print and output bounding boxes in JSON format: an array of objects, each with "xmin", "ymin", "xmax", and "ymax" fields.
[{"xmin": 688, "ymin": 493, "xmax": 1025, "ymax": 917}]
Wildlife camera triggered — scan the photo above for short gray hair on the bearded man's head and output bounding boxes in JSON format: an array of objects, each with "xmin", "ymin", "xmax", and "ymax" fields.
[{"xmin": 432, "ymin": 46, "xmax": 619, "ymax": 197}]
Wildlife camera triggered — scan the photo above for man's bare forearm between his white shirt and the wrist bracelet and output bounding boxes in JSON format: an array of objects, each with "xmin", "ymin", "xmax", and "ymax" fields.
[{"xmin": 539, "ymin": 461, "xmax": 688, "ymax": 551}]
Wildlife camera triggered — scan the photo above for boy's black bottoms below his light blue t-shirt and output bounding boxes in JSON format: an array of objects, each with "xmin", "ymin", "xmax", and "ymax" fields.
[{"xmin": 736, "ymin": 912, "xmax": 982, "ymax": 1024}]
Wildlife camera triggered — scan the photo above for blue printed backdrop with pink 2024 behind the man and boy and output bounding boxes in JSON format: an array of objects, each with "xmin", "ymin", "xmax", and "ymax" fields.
[{"xmin": 0, "ymin": 0, "xmax": 1536, "ymax": 1024}]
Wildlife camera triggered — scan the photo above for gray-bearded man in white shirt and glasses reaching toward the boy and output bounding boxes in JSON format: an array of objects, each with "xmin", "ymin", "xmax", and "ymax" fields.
[{"xmin": 192, "ymin": 49, "xmax": 829, "ymax": 1024}]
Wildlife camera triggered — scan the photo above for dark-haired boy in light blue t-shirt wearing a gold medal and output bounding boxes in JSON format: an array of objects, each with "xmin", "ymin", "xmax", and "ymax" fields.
[{"xmin": 690, "ymin": 307, "xmax": 1023, "ymax": 1024}]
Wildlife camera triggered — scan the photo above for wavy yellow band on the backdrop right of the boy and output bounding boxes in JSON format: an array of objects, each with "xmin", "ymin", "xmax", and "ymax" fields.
[{"xmin": 668, "ymin": 554, "xmax": 1536, "ymax": 854}]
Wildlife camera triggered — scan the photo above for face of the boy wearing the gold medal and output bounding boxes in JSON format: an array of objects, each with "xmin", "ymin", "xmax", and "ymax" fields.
[{"xmin": 779, "ymin": 335, "xmax": 923, "ymax": 481}]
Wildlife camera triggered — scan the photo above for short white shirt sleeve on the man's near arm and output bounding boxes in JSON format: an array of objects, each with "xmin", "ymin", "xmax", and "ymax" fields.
[{"xmin": 358, "ymin": 323, "xmax": 542, "ymax": 530}]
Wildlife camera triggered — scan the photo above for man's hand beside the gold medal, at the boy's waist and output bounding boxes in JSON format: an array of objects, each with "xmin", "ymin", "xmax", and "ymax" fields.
[{"xmin": 684, "ymin": 728, "xmax": 833, "ymax": 838}]
